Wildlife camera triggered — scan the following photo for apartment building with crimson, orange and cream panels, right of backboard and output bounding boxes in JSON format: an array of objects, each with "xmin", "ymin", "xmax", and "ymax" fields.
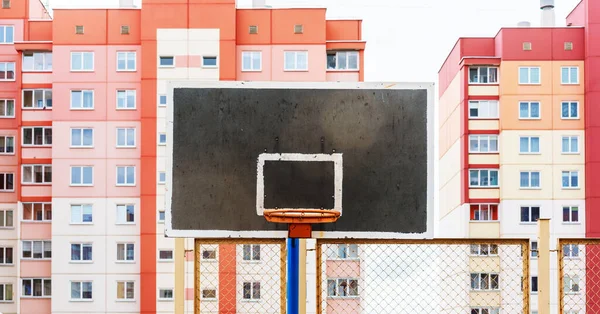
[{"xmin": 439, "ymin": 0, "xmax": 600, "ymax": 313}]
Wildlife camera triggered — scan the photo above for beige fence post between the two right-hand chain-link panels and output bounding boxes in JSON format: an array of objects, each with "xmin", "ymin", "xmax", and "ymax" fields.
[{"xmin": 527, "ymin": 219, "xmax": 550, "ymax": 313}]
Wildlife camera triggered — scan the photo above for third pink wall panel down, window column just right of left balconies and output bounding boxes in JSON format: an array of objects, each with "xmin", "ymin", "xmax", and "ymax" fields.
[{"xmin": 52, "ymin": 121, "xmax": 107, "ymax": 160}]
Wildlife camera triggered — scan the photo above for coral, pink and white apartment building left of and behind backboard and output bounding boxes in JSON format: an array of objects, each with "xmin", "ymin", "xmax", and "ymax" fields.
[{"xmin": 0, "ymin": 0, "xmax": 365, "ymax": 314}]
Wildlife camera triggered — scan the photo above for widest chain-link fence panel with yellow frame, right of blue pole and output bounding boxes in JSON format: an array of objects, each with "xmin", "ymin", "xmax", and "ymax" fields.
[{"xmin": 317, "ymin": 239, "xmax": 530, "ymax": 314}]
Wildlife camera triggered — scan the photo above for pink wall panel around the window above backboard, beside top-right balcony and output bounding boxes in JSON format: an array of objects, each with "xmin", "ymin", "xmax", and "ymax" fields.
[{"xmin": 272, "ymin": 45, "xmax": 326, "ymax": 82}]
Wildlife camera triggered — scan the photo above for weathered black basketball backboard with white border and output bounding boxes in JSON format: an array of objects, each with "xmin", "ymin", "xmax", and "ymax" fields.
[{"xmin": 165, "ymin": 82, "xmax": 433, "ymax": 238}]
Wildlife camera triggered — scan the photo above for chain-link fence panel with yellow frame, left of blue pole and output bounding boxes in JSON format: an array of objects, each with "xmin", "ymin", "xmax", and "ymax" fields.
[{"xmin": 195, "ymin": 239, "xmax": 286, "ymax": 314}]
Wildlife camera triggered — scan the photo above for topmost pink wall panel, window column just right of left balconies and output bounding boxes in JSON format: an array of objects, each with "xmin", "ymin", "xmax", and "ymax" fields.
[{"xmin": 52, "ymin": 45, "xmax": 108, "ymax": 83}]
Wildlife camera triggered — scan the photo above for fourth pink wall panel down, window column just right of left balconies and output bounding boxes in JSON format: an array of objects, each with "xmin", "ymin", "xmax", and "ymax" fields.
[{"xmin": 52, "ymin": 159, "xmax": 107, "ymax": 198}]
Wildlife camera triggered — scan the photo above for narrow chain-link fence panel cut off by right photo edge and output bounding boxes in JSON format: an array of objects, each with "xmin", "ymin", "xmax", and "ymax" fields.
[{"xmin": 558, "ymin": 239, "xmax": 600, "ymax": 314}]
